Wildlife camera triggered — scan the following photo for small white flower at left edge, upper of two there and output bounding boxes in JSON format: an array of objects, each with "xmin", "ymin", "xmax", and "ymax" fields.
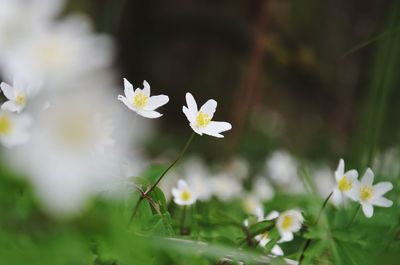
[{"xmin": 0, "ymin": 78, "xmax": 37, "ymax": 113}]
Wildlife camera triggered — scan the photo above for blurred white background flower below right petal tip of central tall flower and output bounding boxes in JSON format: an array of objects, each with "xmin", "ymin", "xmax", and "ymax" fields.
[{"xmin": 211, "ymin": 173, "xmax": 243, "ymax": 202}]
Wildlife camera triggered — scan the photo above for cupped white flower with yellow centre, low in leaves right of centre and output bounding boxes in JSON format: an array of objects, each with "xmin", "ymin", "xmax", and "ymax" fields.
[{"xmin": 276, "ymin": 210, "xmax": 304, "ymax": 242}]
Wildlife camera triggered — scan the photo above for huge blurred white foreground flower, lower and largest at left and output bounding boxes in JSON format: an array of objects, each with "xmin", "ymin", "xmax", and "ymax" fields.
[{"xmin": 5, "ymin": 87, "xmax": 136, "ymax": 216}]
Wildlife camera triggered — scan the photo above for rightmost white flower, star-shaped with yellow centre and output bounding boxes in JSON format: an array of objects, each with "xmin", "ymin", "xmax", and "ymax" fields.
[{"xmin": 355, "ymin": 168, "xmax": 393, "ymax": 218}]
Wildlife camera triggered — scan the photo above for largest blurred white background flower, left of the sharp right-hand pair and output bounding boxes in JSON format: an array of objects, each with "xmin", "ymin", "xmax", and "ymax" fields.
[{"xmin": 265, "ymin": 150, "xmax": 304, "ymax": 193}]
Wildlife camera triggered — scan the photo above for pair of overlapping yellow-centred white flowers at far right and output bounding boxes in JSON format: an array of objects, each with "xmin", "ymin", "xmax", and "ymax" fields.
[{"xmin": 333, "ymin": 159, "xmax": 393, "ymax": 218}]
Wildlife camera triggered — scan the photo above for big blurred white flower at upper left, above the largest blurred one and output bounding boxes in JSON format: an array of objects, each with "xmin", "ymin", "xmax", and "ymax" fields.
[{"xmin": 1, "ymin": 14, "xmax": 113, "ymax": 87}]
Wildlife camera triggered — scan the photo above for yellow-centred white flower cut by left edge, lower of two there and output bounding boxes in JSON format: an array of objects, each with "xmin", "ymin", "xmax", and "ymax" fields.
[{"xmin": 0, "ymin": 111, "xmax": 32, "ymax": 148}]
